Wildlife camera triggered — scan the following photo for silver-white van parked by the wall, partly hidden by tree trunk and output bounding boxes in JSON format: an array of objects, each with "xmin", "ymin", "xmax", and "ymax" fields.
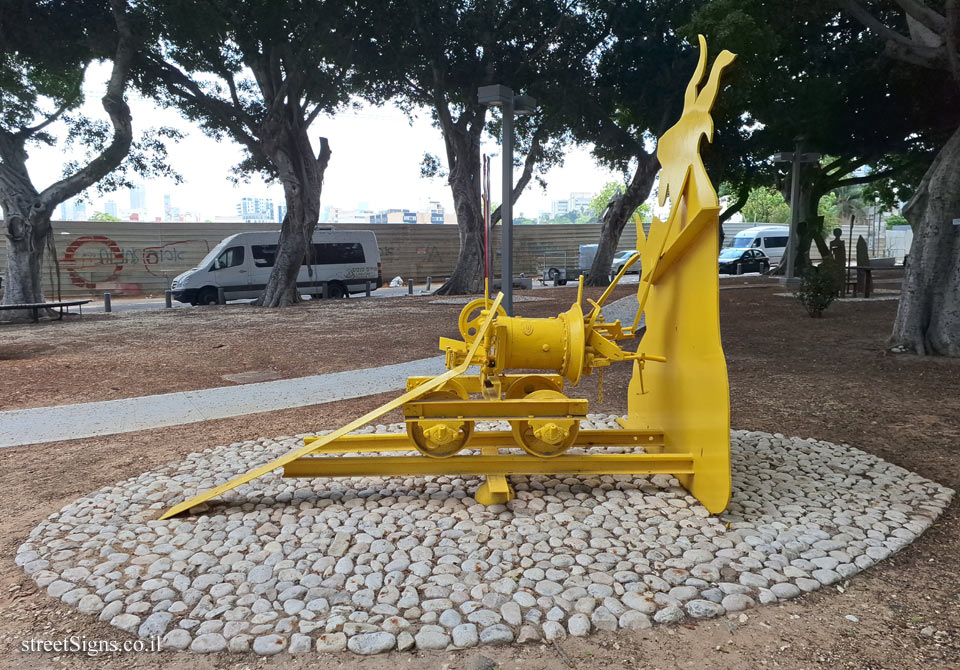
[{"xmin": 170, "ymin": 226, "xmax": 383, "ymax": 305}]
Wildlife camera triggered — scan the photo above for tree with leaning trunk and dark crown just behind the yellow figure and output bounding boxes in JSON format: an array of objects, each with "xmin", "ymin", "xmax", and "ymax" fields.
[{"xmin": 544, "ymin": 0, "xmax": 753, "ymax": 286}]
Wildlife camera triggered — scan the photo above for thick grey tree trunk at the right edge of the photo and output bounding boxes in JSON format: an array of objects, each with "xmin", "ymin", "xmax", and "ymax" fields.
[{"xmin": 890, "ymin": 128, "xmax": 960, "ymax": 357}]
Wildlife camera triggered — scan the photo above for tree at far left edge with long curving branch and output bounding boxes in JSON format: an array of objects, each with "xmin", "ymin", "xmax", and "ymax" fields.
[{"xmin": 0, "ymin": 0, "xmax": 135, "ymax": 318}]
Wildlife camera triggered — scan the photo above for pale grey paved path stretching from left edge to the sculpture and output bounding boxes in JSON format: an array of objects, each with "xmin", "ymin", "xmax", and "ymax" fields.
[{"xmin": 0, "ymin": 356, "xmax": 445, "ymax": 447}]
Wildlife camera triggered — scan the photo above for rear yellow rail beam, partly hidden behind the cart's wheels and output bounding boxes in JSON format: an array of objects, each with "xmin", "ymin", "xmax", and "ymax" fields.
[{"xmin": 303, "ymin": 430, "xmax": 663, "ymax": 454}]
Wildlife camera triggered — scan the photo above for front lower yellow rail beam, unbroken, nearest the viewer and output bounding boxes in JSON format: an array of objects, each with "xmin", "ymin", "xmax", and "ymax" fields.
[{"xmin": 283, "ymin": 453, "xmax": 693, "ymax": 477}]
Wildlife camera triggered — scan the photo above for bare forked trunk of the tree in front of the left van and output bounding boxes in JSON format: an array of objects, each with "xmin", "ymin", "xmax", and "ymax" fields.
[{"xmin": 257, "ymin": 134, "xmax": 331, "ymax": 307}]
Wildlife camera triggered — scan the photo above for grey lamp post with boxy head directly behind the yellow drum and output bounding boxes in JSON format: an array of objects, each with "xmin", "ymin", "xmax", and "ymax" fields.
[{"xmin": 477, "ymin": 84, "xmax": 537, "ymax": 316}]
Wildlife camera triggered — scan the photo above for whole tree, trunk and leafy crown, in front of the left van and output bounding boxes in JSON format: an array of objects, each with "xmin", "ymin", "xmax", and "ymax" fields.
[{"xmin": 138, "ymin": 0, "xmax": 364, "ymax": 307}]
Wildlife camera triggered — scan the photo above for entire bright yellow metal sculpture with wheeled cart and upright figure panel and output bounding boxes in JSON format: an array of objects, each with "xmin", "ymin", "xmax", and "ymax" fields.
[{"xmin": 161, "ymin": 36, "xmax": 734, "ymax": 519}]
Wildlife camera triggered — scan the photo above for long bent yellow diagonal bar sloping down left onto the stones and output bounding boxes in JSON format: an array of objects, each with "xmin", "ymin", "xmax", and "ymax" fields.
[{"xmin": 160, "ymin": 293, "xmax": 503, "ymax": 519}]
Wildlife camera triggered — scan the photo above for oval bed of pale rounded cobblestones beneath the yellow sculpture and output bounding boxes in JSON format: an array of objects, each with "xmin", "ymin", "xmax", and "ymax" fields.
[{"xmin": 16, "ymin": 414, "xmax": 953, "ymax": 655}]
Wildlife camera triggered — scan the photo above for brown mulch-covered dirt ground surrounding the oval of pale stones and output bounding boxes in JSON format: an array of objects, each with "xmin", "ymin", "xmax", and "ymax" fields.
[{"xmin": 0, "ymin": 280, "xmax": 960, "ymax": 670}]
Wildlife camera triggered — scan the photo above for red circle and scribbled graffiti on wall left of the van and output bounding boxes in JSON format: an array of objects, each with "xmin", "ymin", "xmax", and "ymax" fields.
[{"xmin": 60, "ymin": 235, "xmax": 210, "ymax": 291}]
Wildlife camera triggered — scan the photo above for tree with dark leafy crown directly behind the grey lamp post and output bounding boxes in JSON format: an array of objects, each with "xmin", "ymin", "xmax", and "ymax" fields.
[{"xmin": 372, "ymin": 0, "xmax": 603, "ymax": 294}]
